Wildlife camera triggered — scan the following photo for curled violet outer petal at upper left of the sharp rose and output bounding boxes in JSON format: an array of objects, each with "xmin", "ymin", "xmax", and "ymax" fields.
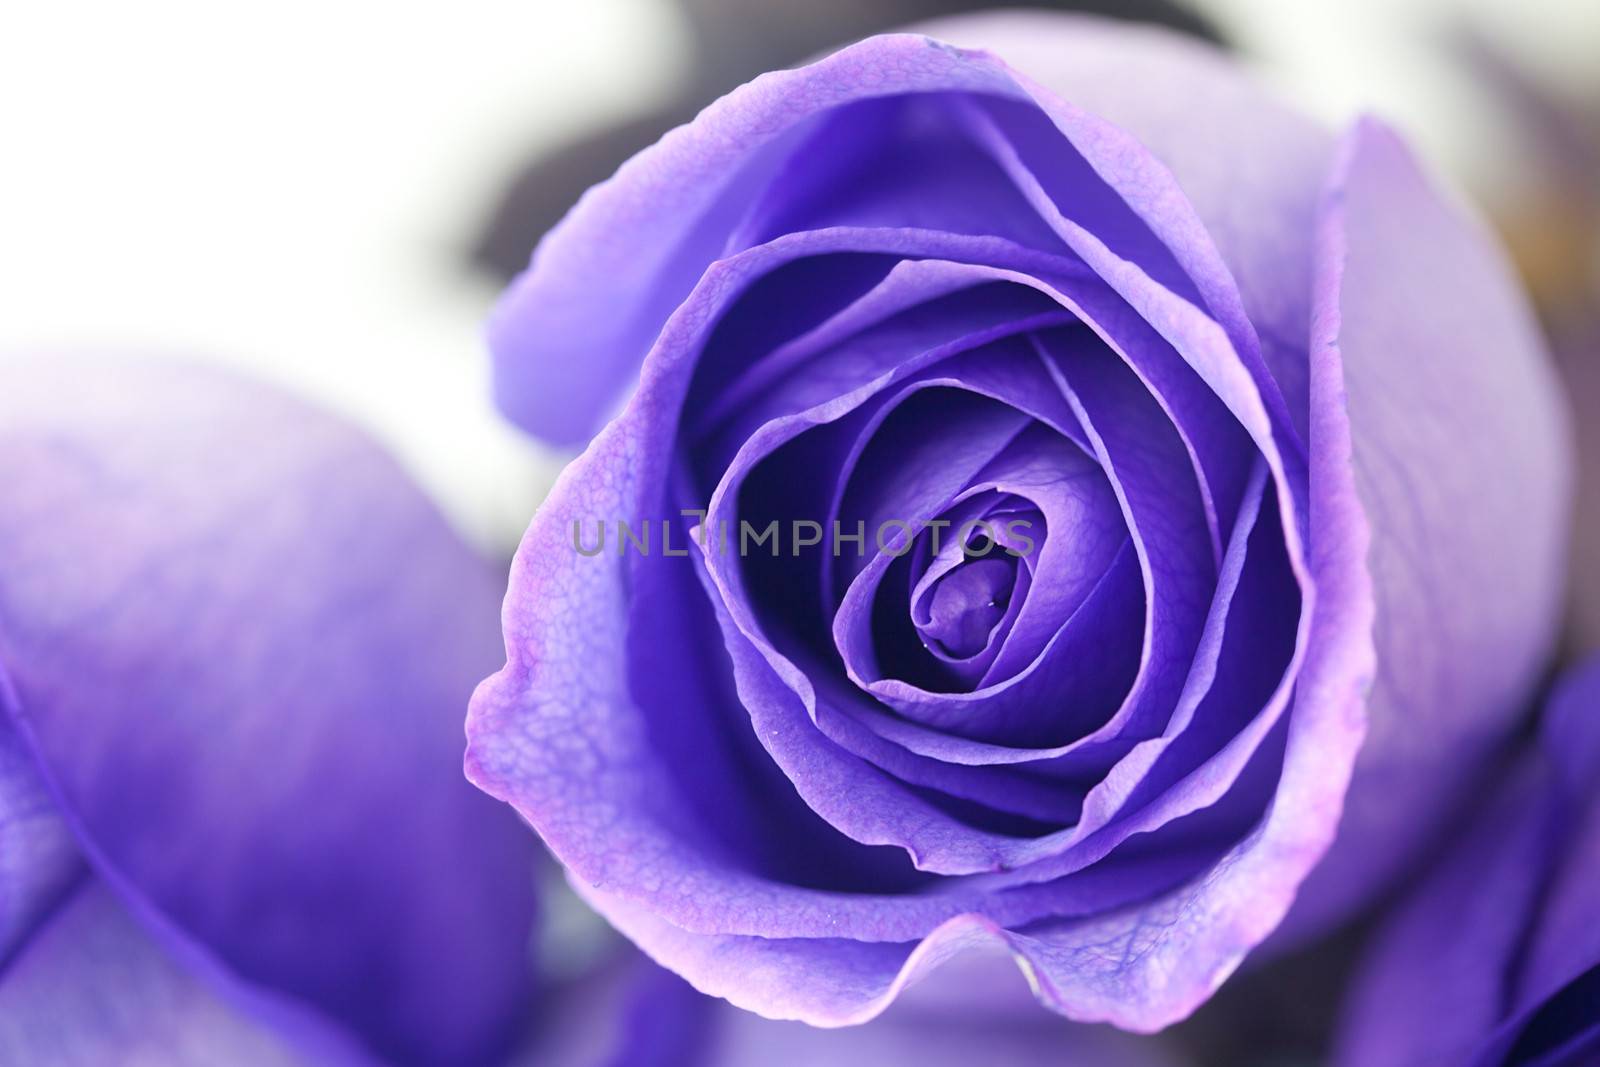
[{"xmin": 490, "ymin": 37, "xmax": 1016, "ymax": 443}]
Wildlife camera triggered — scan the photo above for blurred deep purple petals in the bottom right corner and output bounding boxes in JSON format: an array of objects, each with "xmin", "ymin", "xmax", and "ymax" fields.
[{"xmin": 1336, "ymin": 661, "xmax": 1600, "ymax": 1067}]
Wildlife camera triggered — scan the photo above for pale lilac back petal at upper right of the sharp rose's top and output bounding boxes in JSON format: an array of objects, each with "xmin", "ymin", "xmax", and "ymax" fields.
[{"xmin": 914, "ymin": 11, "xmax": 1334, "ymax": 435}]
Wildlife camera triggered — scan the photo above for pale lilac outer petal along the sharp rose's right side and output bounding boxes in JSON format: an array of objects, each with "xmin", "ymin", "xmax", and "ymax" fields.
[{"xmin": 1290, "ymin": 120, "xmax": 1571, "ymax": 929}]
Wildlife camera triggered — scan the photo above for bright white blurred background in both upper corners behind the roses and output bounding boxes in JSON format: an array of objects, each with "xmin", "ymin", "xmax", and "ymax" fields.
[{"xmin": 0, "ymin": 0, "xmax": 1600, "ymax": 552}]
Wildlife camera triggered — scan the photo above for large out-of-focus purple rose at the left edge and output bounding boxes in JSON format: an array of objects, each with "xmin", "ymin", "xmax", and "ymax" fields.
[{"xmin": 0, "ymin": 357, "xmax": 533, "ymax": 1064}]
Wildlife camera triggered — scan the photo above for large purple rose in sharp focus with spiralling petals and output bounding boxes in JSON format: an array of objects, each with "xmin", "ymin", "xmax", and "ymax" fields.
[{"xmin": 469, "ymin": 16, "xmax": 1566, "ymax": 1029}]
